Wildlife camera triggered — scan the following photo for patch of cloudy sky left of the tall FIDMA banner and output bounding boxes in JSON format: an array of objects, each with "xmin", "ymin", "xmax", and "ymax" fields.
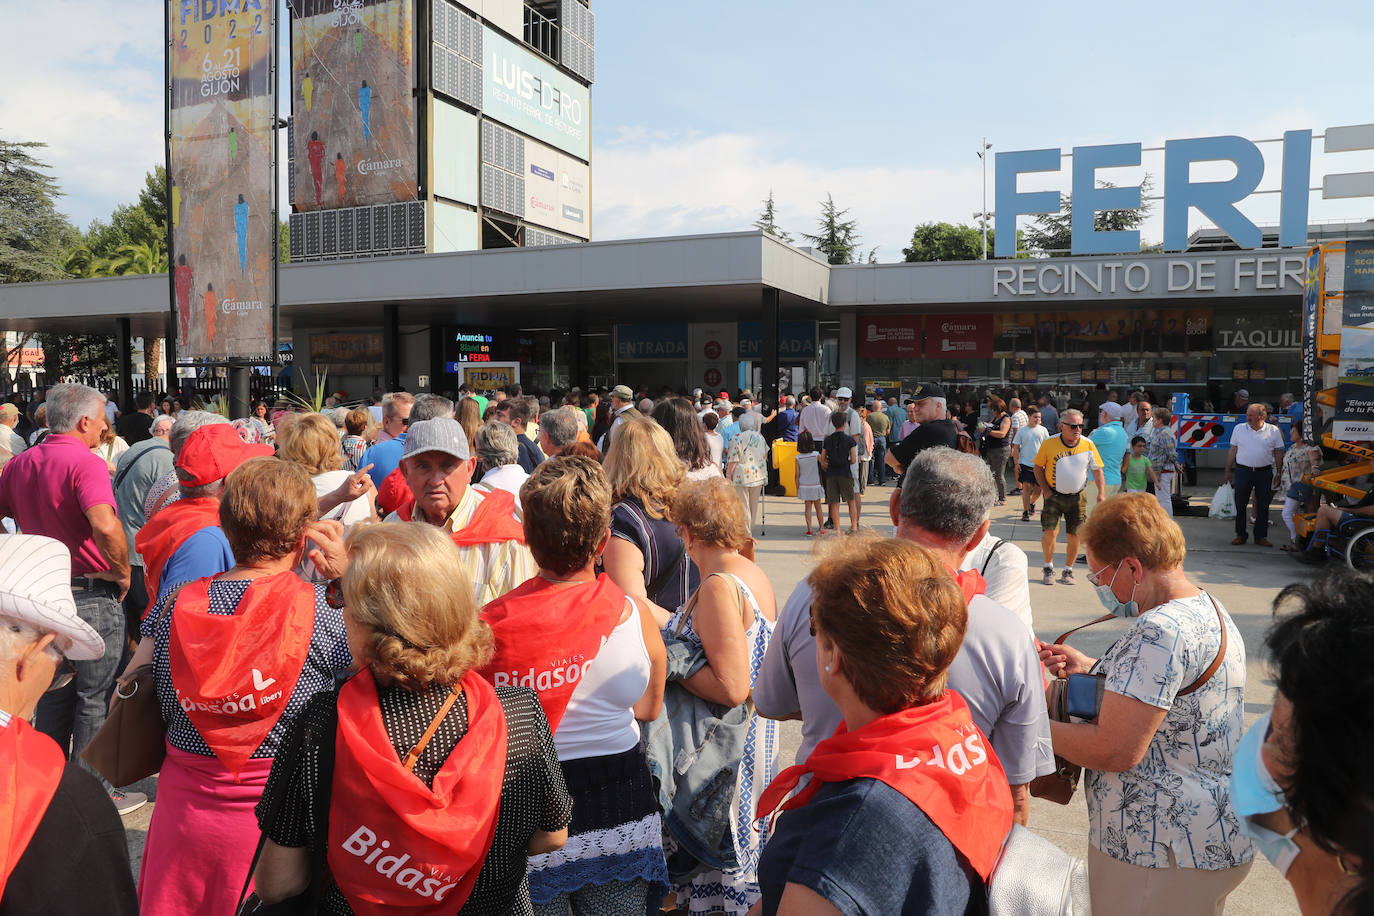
[{"xmin": 0, "ymin": 0, "xmax": 164, "ymax": 227}]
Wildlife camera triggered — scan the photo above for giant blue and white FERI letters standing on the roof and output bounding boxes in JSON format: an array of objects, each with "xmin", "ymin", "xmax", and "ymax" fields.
[{"xmin": 995, "ymin": 124, "xmax": 1374, "ymax": 258}]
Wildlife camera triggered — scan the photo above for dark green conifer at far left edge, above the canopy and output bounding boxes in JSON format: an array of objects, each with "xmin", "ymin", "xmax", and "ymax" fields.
[{"xmin": 0, "ymin": 140, "xmax": 77, "ymax": 283}]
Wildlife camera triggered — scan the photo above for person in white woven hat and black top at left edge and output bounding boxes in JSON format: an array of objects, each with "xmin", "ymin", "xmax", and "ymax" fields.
[{"xmin": 0, "ymin": 534, "xmax": 139, "ymax": 916}]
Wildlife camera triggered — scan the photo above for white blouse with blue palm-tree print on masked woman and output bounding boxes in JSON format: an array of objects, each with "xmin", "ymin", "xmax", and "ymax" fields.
[{"xmin": 1084, "ymin": 592, "xmax": 1254, "ymax": 871}]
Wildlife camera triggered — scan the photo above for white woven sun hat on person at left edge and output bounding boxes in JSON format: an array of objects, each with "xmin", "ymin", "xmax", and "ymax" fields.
[{"xmin": 0, "ymin": 534, "xmax": 104, "ymax": 662}]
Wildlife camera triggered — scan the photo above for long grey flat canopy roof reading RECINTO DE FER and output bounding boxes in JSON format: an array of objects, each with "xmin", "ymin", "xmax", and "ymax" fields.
[{"xmin": 0, "ymin": 231, "xmax": 1305, "ymax": 336}]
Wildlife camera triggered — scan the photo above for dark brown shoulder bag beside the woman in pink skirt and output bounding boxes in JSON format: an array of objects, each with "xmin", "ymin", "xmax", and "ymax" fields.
[{"xmin": 81, "ymin": 586, "xmax": 181, "ymax": 787}]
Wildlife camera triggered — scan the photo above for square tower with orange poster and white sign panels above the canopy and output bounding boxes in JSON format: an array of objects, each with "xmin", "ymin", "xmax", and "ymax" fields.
[{"xmin": 289, "ymin": 0, "xmax": 595, "ymax": 261}]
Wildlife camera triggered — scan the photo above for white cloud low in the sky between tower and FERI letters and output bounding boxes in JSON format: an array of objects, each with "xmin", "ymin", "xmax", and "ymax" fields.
[{"xmin": 592, "ymin": 126, "xmax": 992, "ymax": 261}]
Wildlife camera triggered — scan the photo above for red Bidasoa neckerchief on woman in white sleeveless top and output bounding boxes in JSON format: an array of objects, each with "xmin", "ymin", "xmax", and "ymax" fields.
[{"xmin": 480, "ymin": 573, "xmax": 625, "ymax": 732}]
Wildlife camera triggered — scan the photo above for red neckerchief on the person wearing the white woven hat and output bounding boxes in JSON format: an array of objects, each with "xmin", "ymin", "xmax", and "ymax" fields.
[{"xmin": 0, "ymin": 715, "xmax": 66, "ymax": 894}]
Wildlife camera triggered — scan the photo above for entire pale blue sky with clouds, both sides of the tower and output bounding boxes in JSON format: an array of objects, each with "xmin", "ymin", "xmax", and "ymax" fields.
[{"xmin": 0, "ymin": 0, "xmax": 1374, "ymax": 261}]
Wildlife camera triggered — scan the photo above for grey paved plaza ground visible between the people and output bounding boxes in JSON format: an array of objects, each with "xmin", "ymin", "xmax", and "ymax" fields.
[{"xmin": 124, "ymin": 471, "xmax": 1311, "ymax": 916}]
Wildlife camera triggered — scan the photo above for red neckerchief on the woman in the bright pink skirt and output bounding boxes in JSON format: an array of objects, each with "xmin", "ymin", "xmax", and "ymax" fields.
[{"xmin": 168, "ymin": 571, "xmax": 315, "ymax": 776}]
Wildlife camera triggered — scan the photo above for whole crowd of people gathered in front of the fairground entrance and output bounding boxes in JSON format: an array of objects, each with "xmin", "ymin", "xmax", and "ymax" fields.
[{"xmin": 0, "ymin": 385, "xmax": 1374, "ymax": 916}]
